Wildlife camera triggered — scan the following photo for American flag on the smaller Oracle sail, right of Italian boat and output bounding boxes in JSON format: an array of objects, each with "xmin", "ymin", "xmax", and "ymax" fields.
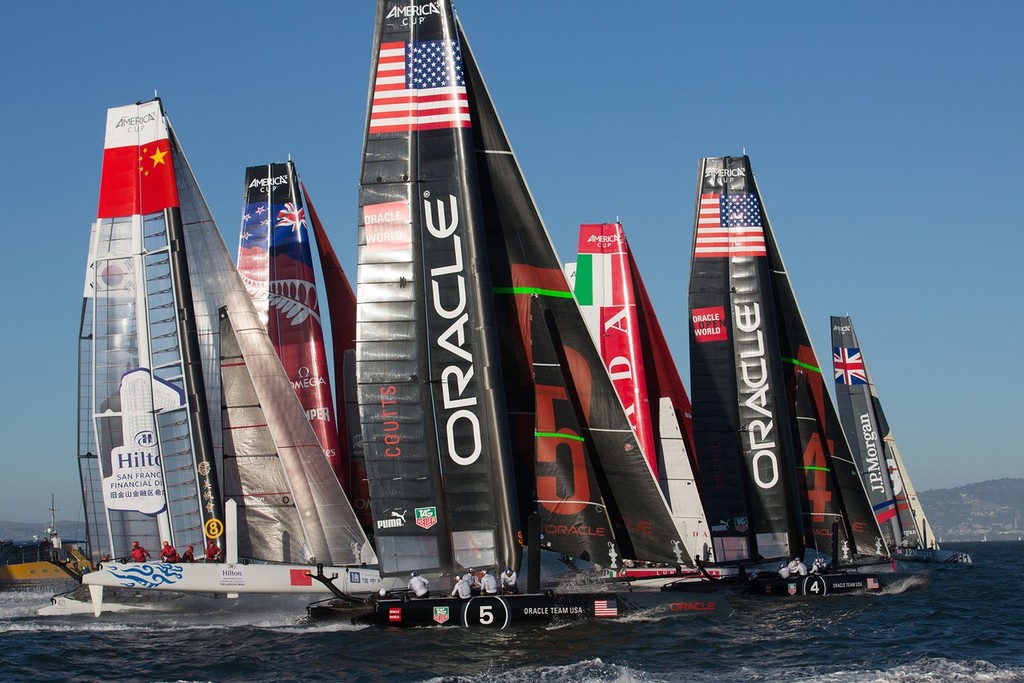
[{"xmin": 693, "ymin": 193, "xmax": 767, "ymax": 258}]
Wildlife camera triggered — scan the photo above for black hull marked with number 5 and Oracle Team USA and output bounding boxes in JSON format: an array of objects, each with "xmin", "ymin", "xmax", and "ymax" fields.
[{"xmin": 307, "ymin": 591, "xmax": 730, "ymax": 629}]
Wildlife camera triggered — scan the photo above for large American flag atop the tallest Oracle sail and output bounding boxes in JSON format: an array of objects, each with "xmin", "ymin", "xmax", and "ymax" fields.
[{"xmin": 370, "ymin": 40, "xmax": 470, "ymax": 133}]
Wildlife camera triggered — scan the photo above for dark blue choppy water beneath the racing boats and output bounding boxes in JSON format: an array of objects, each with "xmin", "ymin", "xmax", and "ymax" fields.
[{"xmin": 0, "ymin": 542, "xmax": 1024, "ymax": 683}]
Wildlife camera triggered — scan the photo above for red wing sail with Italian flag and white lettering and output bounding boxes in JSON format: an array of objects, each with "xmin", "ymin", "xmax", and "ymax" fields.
[{"xmin": 575, "ymin": 223, "xmax": 658, "ymax": 476}]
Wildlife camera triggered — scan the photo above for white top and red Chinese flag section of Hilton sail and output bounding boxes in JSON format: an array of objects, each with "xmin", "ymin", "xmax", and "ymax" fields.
[{"xmin": 96, "ymin": 100, "xmax": 178, "ymax": 218}]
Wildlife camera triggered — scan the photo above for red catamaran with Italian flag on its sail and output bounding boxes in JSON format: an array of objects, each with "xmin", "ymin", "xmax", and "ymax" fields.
[{"xmin": 573, "ymin": 222, "xmax": 713, "ymax": 577}]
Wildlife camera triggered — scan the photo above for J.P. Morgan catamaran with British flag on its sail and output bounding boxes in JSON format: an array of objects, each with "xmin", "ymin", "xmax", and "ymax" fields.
[{"xmin": 830, "ymin": 315, "xmax": 971, "ymax": 563}]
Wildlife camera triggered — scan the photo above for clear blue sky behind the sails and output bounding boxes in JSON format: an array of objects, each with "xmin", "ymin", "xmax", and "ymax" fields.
[{"xmin": 0, "ymin": 0, "xmax": 1024, "ymax": 521}]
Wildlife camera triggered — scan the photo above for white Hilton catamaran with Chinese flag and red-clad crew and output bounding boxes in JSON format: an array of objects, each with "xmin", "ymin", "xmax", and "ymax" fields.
[{"xmin": 62, "ymin": 99, "xmax": 391, "ymax": 614}]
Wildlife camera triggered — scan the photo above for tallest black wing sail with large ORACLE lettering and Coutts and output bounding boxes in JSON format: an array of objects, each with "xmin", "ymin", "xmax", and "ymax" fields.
[{"xmin": 355, "ymin": 0, "xmax": 520, "ymax": 575}]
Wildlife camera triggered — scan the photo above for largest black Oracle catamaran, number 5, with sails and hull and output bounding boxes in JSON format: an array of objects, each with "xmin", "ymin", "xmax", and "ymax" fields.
[{"xmin": 310, "ymin": 0, "xmax": 719, "ymax": 626}]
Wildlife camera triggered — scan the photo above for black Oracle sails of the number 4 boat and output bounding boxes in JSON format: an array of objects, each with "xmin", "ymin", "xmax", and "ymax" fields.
[{"xmin": 690, "ymin": 157, "xmax": 880, "ymax": 562}]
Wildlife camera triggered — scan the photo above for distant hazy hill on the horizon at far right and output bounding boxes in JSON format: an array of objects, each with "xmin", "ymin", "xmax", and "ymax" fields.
[{"xmin": 918, "ymin": 478, "xmax": 1024, "ymax": 544}]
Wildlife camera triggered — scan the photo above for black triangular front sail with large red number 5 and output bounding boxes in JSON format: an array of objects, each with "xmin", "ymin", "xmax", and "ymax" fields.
[{"xmin": 459, "ymin": 13, "xmax": 690, "ymax": 566}]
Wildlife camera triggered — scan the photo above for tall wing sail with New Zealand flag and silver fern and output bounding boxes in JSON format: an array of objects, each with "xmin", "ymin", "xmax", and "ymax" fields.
[{"xmin": 239, "ymin": 162, "xmax": 345, "ymax": 486}]
